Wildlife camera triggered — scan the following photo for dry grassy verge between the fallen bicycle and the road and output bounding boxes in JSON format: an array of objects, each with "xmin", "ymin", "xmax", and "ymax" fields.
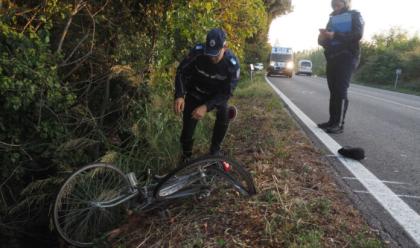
[{"xmin": 114, "ymin": 76, "xmax": 383, "ymax": 248}]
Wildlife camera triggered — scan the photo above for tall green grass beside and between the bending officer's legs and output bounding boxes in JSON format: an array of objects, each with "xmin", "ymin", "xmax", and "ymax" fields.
[{"xmin": 111, "ymin": 78, "xmax": 214, "ymax": 175}]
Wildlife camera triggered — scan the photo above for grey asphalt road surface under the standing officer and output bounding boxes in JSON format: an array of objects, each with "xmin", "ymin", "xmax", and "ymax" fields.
[{"xmin": 269, "ymin": 76, "xmax": 420, "ymax": 247}]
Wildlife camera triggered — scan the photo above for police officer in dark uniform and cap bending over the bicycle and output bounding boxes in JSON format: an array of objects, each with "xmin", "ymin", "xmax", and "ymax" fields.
[{"xmin": 174, "ymin": 28, "xmax": 240, "ymax": 161}]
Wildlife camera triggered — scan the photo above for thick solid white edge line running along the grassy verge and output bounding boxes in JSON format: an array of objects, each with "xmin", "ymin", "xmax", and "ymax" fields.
[{"xmin": 265, "ymin": 77, "xmax": 420, "ymax": 245}]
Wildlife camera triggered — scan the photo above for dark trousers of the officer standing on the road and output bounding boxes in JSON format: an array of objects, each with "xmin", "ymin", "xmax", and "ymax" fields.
[{"xmin": 327, "ymin": 53, "xmax": 357, "ymax": 125}]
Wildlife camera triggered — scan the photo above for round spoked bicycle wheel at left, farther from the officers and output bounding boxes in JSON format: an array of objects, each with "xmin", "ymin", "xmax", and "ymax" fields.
[{"xmin": 54, "ymin": 164, "xmax": 133, "ymax": 247}]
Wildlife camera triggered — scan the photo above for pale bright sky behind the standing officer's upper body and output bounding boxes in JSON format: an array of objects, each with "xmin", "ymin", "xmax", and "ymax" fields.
[{"xmin": 269, "ymin": 0, "xmax": 420, "ymax": 51}]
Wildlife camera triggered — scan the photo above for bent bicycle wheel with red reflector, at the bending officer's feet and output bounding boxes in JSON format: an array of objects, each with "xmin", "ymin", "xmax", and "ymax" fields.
[{"xmin": 154, "ymin": 156, "xmax": 256, "ymax": 200}]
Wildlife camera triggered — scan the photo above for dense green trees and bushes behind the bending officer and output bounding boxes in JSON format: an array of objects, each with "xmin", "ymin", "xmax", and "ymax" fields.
[{"xmin": 0, "ymin": 0, "xmax": 290, "ymax": 247}]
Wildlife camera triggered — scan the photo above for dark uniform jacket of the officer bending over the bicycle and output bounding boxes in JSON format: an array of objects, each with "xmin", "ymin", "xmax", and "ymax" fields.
[{"xmin": 175, "ymin": 44, "xmax": 240, "ymax": 111}]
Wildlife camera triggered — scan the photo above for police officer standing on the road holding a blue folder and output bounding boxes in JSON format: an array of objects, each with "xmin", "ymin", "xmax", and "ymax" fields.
[{"xmin": 318, "ymin": 0, "xmax": 364, "ymax": 133}]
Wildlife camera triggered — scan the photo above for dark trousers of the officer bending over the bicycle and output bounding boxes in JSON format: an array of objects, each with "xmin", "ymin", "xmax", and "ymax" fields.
[{"xmin": 180, "ymin": 95, "xmax": 229, "ymax": 157}]
